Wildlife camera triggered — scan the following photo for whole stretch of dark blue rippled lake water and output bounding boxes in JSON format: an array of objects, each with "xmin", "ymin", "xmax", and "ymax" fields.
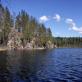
[{"xmin": 0, "ymin": 48, "xmax": 82, "ymax": 82}]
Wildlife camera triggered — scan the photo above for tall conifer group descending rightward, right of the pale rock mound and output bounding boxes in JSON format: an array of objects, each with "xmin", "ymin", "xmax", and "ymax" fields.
[{"xmin": 16, "ymin": 11, "xmax": 52, "ymax": 45}]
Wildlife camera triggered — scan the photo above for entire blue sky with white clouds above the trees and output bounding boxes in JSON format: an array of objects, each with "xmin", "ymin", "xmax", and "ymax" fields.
[{"xmin": 1, "ymin": 0, "xmax": 82, "ymax": 37}]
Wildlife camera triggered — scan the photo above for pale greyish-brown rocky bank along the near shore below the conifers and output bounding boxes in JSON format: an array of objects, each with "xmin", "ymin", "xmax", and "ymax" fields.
[{"xmin": 7, "ymin": 29, "xmax": 54, "ymax": 50}]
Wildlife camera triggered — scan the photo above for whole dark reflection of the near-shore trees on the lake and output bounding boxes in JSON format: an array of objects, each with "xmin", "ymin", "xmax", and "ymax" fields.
[{"xmin": 0, "ymin": 50, "xmax": 47, "ymax": 82}]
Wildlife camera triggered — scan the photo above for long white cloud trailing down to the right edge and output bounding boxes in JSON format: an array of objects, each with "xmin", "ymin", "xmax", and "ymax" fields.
[{"xmin": 66, "ymin": 19, "xmax": 82, "ymax": 34}]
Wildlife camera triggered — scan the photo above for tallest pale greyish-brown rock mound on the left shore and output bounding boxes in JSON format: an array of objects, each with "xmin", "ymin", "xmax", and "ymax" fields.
[{"xmin": 7, "ymin": 28, "xmax": 23, "ymax": 49}]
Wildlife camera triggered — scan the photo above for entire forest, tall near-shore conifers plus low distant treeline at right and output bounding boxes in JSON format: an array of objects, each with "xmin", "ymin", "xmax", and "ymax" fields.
[{"xmin": 0, "ymin": 4, "xmax": 82, "ymax": 47}]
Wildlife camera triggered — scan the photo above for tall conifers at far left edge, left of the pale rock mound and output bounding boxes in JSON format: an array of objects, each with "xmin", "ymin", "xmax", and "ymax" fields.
[{"xmin": 0, "ymin": 4, "xmax": 13, "ymax": 44}]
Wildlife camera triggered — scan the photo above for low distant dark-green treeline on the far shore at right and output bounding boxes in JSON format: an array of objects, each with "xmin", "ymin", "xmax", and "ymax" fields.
[{"xmin": 54, "ymin": 37, "xmax": 82, "ymax": 47}]
